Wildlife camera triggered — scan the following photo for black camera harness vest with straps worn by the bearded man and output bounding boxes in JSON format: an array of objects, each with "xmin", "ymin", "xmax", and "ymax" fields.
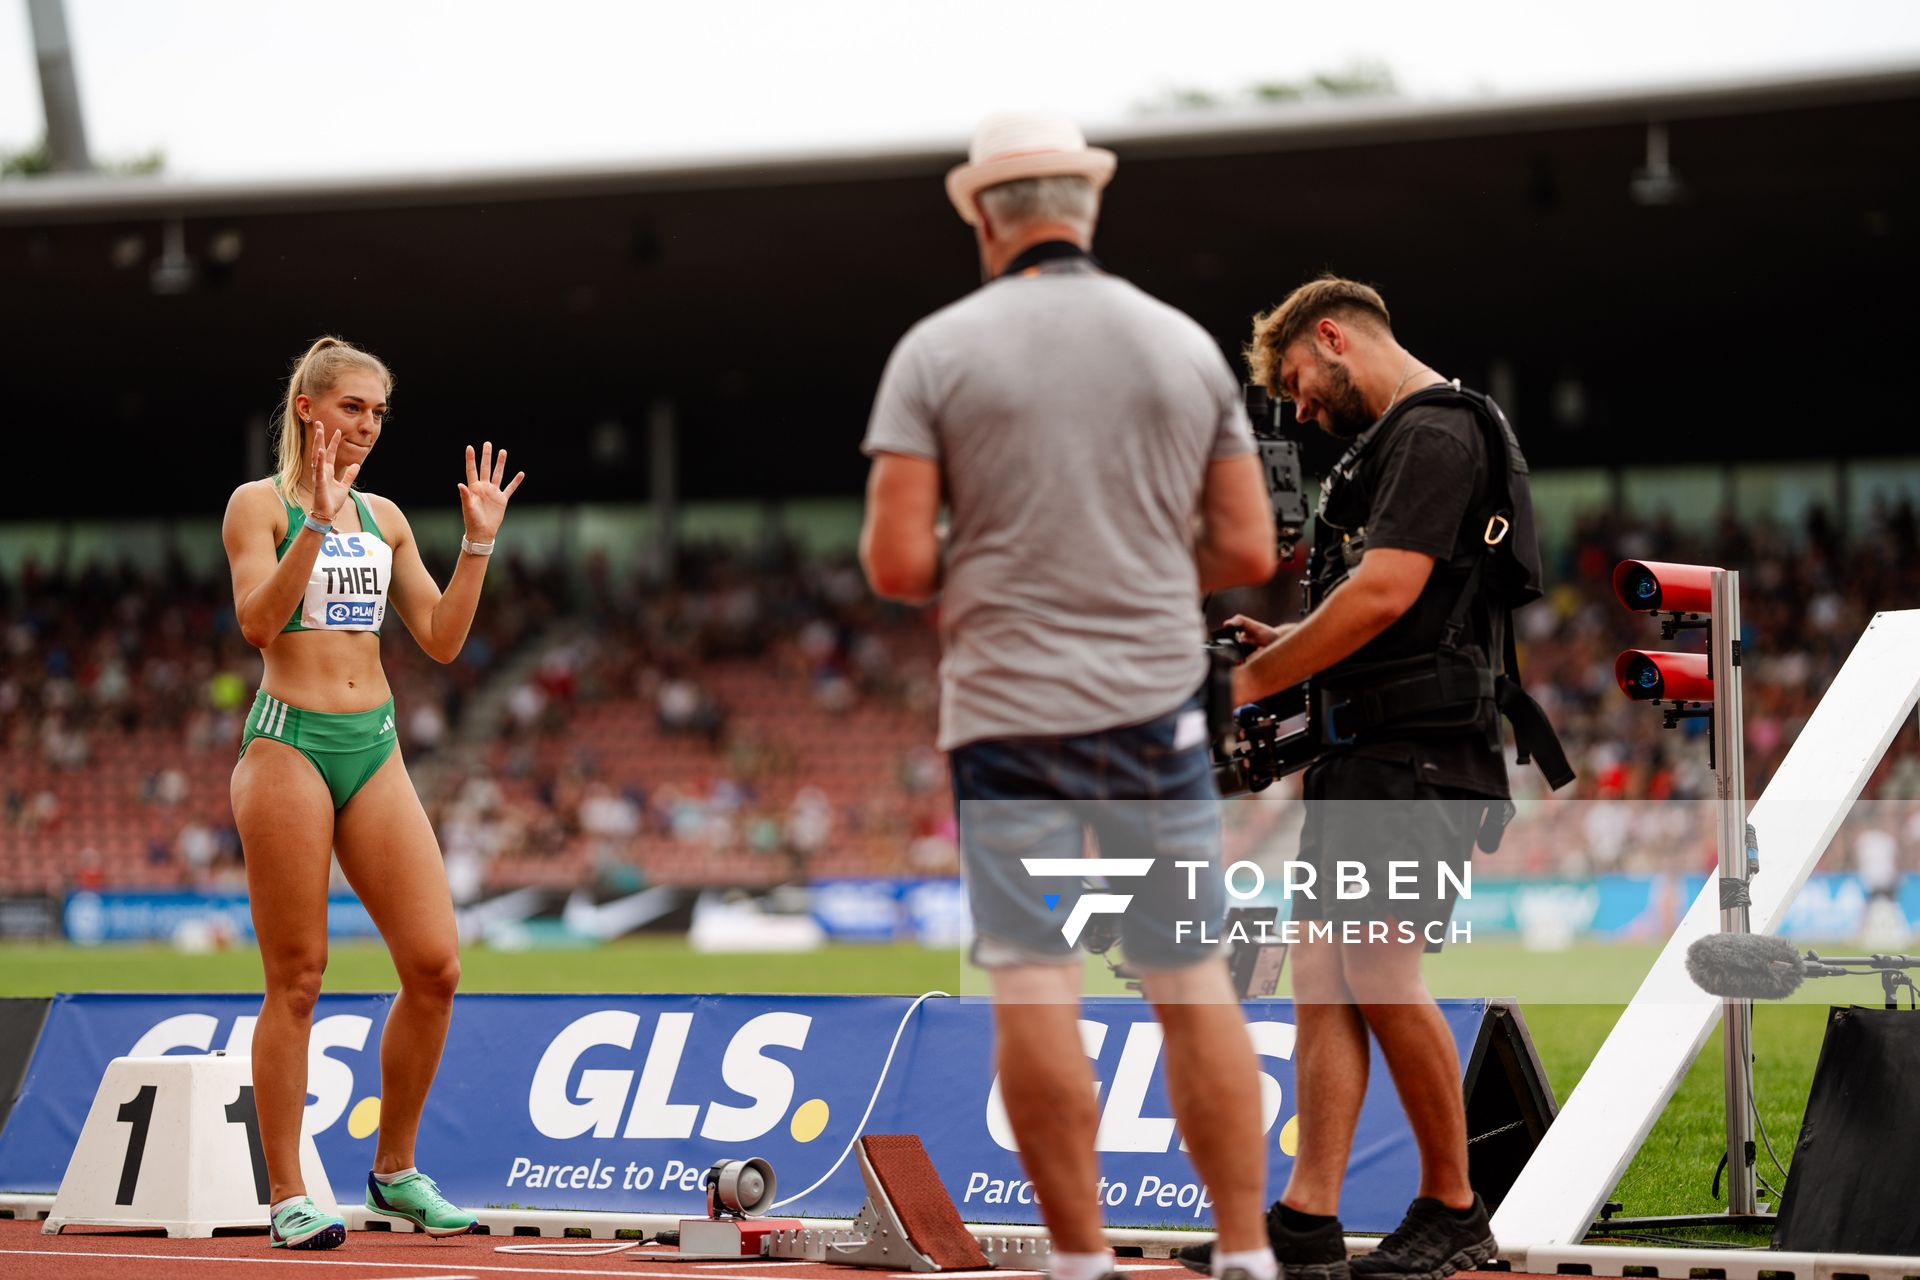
[{"xmin": 1308, "ymin": 382, "xmax": 1572, "ymax": 791}]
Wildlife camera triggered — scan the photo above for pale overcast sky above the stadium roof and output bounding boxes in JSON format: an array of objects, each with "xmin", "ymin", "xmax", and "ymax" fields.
[{"xmin": 0, "ymin": 0, "xmax": 1920, "ymax": 177}]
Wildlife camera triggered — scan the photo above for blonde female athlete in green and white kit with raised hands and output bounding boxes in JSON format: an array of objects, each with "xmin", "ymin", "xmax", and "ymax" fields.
[{"xmin": 221, "ymin": 338, "xmax": 526, "ymax": 1249}]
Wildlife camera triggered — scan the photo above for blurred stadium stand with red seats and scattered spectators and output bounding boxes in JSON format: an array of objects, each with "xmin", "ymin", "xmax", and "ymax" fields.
[{"xmin": 0, "ymin": 501, "xmax": 1920, "ymax": 900}]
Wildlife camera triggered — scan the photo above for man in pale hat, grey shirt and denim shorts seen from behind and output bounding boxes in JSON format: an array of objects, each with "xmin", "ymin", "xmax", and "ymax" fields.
[{"xmin": 860, "ymin": 113, "xmax": 1282, "ymax": 1280}]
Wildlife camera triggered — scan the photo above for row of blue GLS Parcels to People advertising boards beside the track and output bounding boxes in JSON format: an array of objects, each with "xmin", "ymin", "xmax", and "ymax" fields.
[{"xmin": 0, "ymin": 996, "xmax": 1486, "ymax": 1232}]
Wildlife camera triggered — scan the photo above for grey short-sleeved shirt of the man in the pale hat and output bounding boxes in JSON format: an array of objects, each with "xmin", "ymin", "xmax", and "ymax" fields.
[{"xmin": 862, "ymin": 259, "xmax": 1254, "ymax": 750}]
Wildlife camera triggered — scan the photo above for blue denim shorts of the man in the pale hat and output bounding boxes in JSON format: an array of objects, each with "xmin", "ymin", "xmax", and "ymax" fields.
[{"xmin": 950, "ymin": 697, "xmax": 1227, "ymax": 969}]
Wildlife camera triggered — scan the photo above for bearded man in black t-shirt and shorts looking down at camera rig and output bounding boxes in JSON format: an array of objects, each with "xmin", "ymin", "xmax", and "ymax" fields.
[{"xmin": 1205, "ymin": 276, "xmax": 1551, "ymax": 1280}]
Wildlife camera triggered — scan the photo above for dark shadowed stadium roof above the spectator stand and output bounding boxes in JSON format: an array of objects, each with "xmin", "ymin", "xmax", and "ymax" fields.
[{"xmin": 11, "ymin": 65, "xmax": 1920, "ymax": 516}]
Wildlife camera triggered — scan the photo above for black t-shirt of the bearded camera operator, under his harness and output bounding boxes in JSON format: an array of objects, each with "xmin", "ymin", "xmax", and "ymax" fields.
[{"xmin": 1327, "ymin": 405, "xmax": 1507, "ymax": 796}]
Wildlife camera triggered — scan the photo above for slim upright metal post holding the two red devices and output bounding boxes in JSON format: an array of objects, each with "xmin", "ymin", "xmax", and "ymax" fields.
[{"xmin": 1709, "ymin": 570, "xmax": 1759, "ymax": 1217}]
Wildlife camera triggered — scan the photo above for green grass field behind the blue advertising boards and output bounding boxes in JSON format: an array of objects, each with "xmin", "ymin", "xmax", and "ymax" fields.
[{"xmin": 0, "ymin": 938, "xmax": 1880, "ymax": 1242}]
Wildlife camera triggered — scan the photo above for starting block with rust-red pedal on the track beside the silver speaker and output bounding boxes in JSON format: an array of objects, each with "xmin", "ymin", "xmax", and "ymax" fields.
[{"xmin": 766, "ymin": 1134, "xmax": 1006, "ymax": 1272}]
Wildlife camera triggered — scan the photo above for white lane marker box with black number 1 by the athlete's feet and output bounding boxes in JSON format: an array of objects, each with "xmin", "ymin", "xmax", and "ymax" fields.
[{"xmin": 40, "ymin": 1054, "xmax": 338, "ymax": 1238}]
